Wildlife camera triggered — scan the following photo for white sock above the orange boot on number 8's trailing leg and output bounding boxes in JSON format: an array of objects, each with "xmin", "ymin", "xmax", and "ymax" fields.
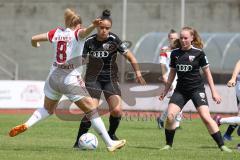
[{"xmin": 25, "ymin": 108, "xmax": 50, "ymax": 128}]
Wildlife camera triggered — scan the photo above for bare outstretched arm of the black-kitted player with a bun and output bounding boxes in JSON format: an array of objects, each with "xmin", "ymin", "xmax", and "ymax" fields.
[{"xmin": 124, "ymin": 50, "xmax": 146, "ymax": 85}]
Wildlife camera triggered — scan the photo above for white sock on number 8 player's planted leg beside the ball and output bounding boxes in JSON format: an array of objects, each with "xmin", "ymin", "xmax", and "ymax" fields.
[{"xmin": 90, "ymin": 113, "xmax": 114, "ymax": 147}]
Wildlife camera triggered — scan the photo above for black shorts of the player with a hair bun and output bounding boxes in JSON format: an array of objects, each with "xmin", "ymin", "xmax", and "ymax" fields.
[{"xmin": 86, "ymin": 81, "xmax": 121, "ymax": 99}]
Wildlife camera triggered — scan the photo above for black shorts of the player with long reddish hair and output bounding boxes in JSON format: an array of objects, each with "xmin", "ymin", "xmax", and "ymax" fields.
[{"xmin": 169, "ymin": 89, "xmax": 208, "ymax": 110}]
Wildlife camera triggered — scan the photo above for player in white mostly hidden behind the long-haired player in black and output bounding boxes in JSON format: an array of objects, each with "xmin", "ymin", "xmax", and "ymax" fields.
[{"xmin": 157, "ymin": 29, "xmax": 182, "ymax": 128}]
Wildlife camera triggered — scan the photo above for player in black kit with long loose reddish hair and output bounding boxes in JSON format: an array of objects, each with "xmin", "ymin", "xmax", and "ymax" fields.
[{"xmin": 159, "ymin": 27, "xmax": 231, "ymax": 152}]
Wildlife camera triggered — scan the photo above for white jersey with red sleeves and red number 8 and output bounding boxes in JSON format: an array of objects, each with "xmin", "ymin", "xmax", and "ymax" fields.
[{"xmin": 48, "ymin": 27, "xmax": 84, "ymax": 74}]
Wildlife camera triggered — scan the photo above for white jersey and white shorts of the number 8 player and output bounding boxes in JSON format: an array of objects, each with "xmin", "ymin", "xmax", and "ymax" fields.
[{"xmin": 44, "ymin": 27, "xmax": 89, "ymax": 102}]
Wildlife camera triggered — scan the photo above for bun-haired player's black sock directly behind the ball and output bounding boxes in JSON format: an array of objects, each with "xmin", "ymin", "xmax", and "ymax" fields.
[{"xmin": 74, "ymin": 116, "xmax": 91, "ymax": 145}]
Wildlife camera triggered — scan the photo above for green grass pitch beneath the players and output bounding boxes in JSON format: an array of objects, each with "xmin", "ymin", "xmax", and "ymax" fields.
[{"xmin": 0, "ymin": 114, "xmax": 240, "ymax": 160}]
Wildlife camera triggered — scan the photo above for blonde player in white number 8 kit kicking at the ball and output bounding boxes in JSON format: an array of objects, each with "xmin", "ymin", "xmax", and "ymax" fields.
[{"xmin": 9, "ymin": 9, "xmax": 126, "ymax": 151}]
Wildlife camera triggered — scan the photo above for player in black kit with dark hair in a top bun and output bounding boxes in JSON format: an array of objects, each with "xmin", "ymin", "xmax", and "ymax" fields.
[{"xmin": 74, "ymin": 10, "xmax": 146, "ymax": 147}]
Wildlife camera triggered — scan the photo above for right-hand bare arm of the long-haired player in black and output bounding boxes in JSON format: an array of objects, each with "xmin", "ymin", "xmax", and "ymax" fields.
[{"xmin": 202, "ymin": 66, "xmax": 222, "ymax": 104}]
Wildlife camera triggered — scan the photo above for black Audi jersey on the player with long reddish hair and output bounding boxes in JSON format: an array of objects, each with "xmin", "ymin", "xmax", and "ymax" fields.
[{"xmin": 170, "ymin": 47, "xmax": 209, "ymax": 92}]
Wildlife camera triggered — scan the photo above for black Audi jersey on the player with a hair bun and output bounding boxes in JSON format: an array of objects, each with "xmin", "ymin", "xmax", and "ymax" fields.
[{"xmin": 83, "ymin": 33, "xmax": 127, "ymax": 81}]
